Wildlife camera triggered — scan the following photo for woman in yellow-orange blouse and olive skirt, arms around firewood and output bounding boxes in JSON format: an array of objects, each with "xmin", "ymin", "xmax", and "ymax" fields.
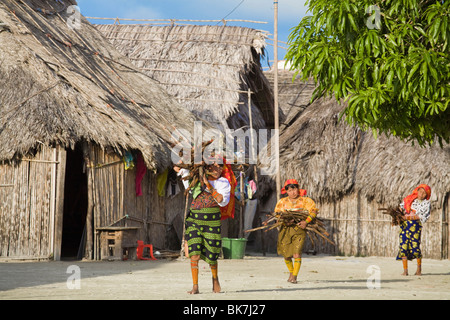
[{"xmin": 275, "ymin": 179, "xmax": 317, "ymax": 283}]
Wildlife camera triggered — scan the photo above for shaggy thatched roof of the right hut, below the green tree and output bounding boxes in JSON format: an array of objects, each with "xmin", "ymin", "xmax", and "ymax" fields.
[{"xmin": 260, "ymin": 98, "xmax": 450, "ymax": 207}]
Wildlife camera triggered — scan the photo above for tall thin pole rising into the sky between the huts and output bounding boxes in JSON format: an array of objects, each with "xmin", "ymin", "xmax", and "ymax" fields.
[{"xmin": 273, "ymin": 0, "xmax": 281, "ymax": 202}]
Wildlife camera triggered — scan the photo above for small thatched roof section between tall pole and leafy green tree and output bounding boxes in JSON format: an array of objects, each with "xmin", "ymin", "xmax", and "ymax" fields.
[{"xmin": 264, "ymin": 69, "xmax": 316, "ymax": 130}]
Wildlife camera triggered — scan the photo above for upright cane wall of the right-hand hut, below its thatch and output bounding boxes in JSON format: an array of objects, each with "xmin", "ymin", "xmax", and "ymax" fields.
[{"xmin": 255, "ymin": 190, "xmax": 450, "ymax": 259}]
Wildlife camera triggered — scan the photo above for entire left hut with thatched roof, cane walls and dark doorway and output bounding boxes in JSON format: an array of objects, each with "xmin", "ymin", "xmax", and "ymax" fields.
[{"xmin": 0, "ymin": 0, "xmax": 202, "ymax": 259}]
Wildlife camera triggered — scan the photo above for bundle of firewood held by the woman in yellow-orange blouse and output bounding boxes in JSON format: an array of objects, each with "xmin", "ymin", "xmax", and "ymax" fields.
[{"xmin": 245, "ymin": 209, "xmax": 335, "ymax": 245}]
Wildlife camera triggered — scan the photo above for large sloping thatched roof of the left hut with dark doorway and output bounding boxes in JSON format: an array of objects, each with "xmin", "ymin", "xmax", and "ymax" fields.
[{"xmin": 0, "ymin": 0, "xmax": 200, "ymax": 169}]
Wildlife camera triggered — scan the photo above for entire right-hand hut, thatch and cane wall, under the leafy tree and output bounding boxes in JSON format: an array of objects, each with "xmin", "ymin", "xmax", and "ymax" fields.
[{"xmin": 259, "ymin": 99, "xmax": 450, "ymax": 258}]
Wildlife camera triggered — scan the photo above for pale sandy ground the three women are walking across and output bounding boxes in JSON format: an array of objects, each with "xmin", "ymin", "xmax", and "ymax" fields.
[{"xmin": 0, "ymin": 254, "xmax": 450, "ymax": 301}]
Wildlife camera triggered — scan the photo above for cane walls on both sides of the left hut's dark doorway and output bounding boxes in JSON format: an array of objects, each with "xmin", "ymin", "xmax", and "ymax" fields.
[{"xmin": 0, "ymin": 144, "xmax": 184, "ymax": 259}]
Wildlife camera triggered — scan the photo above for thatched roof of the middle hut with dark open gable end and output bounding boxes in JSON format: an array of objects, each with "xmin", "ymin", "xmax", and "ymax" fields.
[{"xmin": 96, "ymin": 25, "xmax": 273, "ymax": 129}]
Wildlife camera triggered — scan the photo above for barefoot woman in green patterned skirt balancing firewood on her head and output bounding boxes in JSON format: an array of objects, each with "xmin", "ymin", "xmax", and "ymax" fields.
[{"xmin": 174, "ymin": 159, "xmax": 236, "ymax": 294}]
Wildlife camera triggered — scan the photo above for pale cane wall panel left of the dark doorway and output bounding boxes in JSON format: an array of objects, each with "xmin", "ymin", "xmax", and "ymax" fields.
[{"xmin": 0, "ymin": 147, "xmax": 58, "ymax": 259}]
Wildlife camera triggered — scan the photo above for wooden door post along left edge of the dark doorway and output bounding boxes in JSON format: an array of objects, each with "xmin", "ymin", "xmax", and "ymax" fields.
[{"xmin": 53, "ymin": 146, "xmax": 67, "ymax": 260}]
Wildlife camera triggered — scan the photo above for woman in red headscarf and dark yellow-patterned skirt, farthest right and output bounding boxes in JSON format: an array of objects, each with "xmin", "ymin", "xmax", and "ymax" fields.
[{"xmin": 397, "ymin": 184, "xmax": 431, "ymax": 276}]
